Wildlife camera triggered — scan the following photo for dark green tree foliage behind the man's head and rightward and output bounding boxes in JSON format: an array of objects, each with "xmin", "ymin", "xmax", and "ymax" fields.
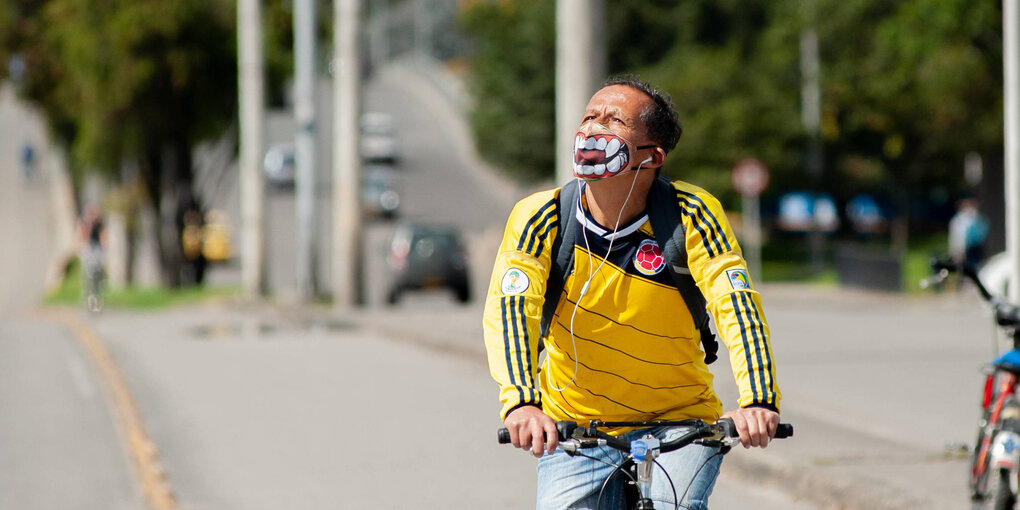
[{"xmin": 464, "ymin": 0, "xmax": 1003, "ymax": 210}]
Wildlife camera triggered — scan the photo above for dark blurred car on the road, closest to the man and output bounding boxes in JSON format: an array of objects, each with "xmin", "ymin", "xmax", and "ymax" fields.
[{"xmin": 387, "ymin": 223, "xmax": 471, "ymax": 304}]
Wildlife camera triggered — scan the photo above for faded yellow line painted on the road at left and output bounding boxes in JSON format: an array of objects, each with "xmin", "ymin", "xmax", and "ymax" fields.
[{"xmin": 60, "ymin": 311, "xmax": 177, "ymax": 510}]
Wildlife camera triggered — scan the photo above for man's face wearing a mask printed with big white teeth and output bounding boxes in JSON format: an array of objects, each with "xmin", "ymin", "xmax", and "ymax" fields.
[{"xmin": 573, "ymin": 85, "xmax": 654, "ymax": 180}]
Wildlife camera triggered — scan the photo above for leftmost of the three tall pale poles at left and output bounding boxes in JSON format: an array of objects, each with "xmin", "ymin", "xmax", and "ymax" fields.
[{"xmin": 238, "ymin": 0, "xmax": 265, "ymax": 296}]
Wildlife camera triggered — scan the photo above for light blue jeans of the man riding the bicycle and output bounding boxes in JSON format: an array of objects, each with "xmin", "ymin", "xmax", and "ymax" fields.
[{"xmin": 537, "ymin": 426, "xmax": 722, "ymax": 510}]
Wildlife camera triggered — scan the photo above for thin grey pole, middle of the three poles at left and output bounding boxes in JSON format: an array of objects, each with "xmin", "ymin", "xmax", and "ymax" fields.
[{"xmin": 294, "ymin": 0, "xmax": 318, "ymax": 301}]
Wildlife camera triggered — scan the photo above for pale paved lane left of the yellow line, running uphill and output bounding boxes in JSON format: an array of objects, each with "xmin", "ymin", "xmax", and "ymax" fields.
[{"xmin": 0, "ymin": 87, "xmax": 144, "ymax": 510}]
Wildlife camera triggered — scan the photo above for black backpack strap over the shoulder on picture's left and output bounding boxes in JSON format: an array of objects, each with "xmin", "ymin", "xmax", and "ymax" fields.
[{"xmin": 539, "ymin": 180, "xmax": 580, "ymax": 339}]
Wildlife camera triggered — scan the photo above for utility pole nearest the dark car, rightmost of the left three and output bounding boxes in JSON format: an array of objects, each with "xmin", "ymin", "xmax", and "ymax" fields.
[{"xmin": 333, "ymin": 0, "xmax": 362, "ymax": 310}]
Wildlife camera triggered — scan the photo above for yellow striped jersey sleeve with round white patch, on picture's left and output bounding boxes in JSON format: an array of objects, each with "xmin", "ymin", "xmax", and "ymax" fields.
[{"xmin": 482, "ymin": 191, "xmax": 559, "ymax": 419}]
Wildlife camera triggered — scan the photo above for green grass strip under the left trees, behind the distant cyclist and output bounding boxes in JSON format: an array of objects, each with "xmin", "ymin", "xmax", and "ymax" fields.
[{"xmin": 43, "ymin": 260, "xmax": 238, "ymax": 310}]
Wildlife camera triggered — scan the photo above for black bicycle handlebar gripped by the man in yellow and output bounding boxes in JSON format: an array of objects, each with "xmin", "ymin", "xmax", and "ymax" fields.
[{"xmin": 497, "ymin": 418, "xmax": 794, "ymax": 453}]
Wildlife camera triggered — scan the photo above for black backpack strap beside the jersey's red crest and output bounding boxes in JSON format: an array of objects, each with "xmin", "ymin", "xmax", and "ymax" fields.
[{"xmin": 648, "ymin": 175, "xmax": 719, "ymax": 363}]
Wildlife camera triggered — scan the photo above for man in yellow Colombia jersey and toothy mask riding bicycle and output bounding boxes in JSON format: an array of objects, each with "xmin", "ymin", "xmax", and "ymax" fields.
[{"xmin": 483, "ymin": 77, "xmax": 780, "ymax": 509}]
